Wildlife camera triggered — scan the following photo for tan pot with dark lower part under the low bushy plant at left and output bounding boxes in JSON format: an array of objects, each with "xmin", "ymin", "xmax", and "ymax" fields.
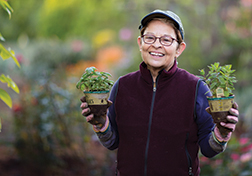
[{"xmin": 84, "ymin": 91, "xmax": 111, "ymax": 125}]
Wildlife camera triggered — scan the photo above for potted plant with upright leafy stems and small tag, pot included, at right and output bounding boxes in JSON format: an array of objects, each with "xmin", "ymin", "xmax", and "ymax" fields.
[{"xmin": 199, "ymin": 62, "xmax": 237, "ymax": 136}]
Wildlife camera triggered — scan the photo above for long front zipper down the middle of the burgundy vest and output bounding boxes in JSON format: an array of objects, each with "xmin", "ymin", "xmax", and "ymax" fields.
[{"xmin": 144, "ymin": 76, "xmax": 159, "ymax": 176}]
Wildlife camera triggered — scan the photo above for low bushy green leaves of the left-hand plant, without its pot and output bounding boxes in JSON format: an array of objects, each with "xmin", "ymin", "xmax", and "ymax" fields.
[{"xmin": 76, "ymin": 67, "xmax": 114, "ymax": 92}]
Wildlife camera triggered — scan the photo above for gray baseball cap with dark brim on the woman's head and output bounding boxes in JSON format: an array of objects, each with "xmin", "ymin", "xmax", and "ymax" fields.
[{"xmin": 139, "ymin": 10, "xmax": 185, "ymax": 39}]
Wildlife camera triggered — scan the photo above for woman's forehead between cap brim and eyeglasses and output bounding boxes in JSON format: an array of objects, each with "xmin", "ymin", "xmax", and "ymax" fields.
[{"xmin": 144, "ymin": 19, "xmax": 176, "ymax": 37}]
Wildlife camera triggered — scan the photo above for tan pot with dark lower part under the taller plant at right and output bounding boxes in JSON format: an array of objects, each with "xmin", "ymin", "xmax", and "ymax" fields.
[{"xmin": 207, "ymin": 96, "xmax": 234, "ymax": 137}]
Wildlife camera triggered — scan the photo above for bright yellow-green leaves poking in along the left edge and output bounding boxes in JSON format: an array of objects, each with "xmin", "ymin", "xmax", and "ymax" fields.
[{"xmin": 0, "ymin": 0, "xmax": 20, "ymax": 108}]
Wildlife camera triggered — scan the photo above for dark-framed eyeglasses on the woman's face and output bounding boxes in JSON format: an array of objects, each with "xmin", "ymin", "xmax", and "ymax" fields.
[{"xmin": 141, "ymin": 34, "xmax": 178, "ymax": 46}]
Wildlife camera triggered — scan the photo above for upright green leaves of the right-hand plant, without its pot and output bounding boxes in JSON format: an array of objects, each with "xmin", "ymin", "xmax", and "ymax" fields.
[{"xmin": 199, "ymin": 62, "xmax": 237, "ymax": 97}]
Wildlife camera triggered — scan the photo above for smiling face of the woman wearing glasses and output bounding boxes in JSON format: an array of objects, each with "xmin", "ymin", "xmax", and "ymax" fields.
[{"xmin": 138, "ymin": 19, "xmax": 186, "ymax": 75}]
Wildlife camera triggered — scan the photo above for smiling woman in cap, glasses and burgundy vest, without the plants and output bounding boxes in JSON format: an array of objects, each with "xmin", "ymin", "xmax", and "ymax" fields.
[{"xmin": 81, "ymin": 10, "xmax": 239, "ymax": 176}]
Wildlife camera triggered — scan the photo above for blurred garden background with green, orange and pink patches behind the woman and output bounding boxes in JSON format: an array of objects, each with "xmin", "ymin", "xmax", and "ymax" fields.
[{"xmin": 0, "ymin": 0, "xmax": 252, "ymax": 176}]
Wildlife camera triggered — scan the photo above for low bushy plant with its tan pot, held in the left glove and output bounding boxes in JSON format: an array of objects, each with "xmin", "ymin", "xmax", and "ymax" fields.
[{"xmin": 76, "ymin": 67, "xmax": 114, "ymax": 125}]
